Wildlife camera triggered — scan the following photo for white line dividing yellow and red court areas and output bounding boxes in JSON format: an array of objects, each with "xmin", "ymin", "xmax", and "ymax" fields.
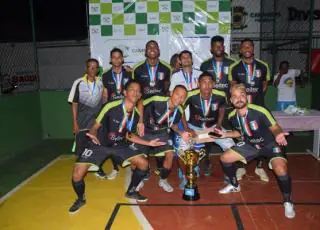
[{"xmin": 124, "ymin": 167, "xmax": 153, "ymax": 230}]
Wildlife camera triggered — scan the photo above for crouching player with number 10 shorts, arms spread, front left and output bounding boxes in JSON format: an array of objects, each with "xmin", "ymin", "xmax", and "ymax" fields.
[{"xmin": 69, "ymin": 81, "xmax": 165, "ymax": 213}]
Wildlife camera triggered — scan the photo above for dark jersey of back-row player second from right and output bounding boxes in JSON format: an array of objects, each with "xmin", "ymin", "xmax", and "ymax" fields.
[{"xmin": 200, "ymin": 57, "xmax": 234, "ymax": 95}]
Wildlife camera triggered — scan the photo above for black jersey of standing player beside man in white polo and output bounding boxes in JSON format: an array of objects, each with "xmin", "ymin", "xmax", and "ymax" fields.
[{"xmin": 102, "ymin": 68, "xmax": 132, "ymax": 101}]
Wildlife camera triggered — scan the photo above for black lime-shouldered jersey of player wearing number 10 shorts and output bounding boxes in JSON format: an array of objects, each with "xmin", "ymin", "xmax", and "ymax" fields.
[{"xmin": 96, "ymin": 100, "xmax": 139, "ymax": 146}]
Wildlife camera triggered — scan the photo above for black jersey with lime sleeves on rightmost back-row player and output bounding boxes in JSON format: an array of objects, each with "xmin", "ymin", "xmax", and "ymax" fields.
[{"xmin": 228, "ymin": 59, "xmax": 270, "ymax": 106}]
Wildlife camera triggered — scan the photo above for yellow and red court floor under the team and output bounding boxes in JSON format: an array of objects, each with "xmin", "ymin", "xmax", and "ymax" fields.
[{"xmin": 0, "ymin": 151, "xmax": 320, "ymax": 230}]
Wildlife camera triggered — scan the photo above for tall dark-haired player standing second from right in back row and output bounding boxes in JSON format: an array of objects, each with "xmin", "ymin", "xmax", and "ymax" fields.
[{"xmin": 200, "ymin": 35, "xmax": 234, "ymax": 96}]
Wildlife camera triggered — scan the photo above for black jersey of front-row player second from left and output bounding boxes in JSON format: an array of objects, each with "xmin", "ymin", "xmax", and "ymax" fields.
[{"xmin": 143, "ymin": 96, "xmax": 183, "ymax": 131}]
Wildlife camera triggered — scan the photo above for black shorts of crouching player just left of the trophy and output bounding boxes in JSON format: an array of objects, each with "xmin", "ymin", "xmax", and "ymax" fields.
[{"xmin": 142, "ymin": 131, "xmax": 174, "ymax": 157}]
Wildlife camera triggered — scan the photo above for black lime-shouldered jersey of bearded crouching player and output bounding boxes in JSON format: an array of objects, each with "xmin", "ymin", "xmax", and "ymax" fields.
[{"xmin": 229, "ymin": 104, "xmax": 277, "ymax": 147}]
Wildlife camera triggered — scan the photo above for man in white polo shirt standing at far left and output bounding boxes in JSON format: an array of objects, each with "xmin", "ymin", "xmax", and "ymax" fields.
[{"xmin": 68, "ymin": 58, "xmax": 106, "ymax": 178}]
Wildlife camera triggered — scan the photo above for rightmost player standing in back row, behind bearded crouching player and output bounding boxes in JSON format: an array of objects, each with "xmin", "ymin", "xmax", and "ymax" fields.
[{"xmin": 228, "ymin": 39, "xmax": 270, "ymax": 182}]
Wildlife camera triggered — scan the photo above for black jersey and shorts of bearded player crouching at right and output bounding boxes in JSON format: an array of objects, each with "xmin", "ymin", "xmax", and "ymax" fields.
[{"xmin": 229, "ymin": 104, "xmax": 286, "ymax": 167}]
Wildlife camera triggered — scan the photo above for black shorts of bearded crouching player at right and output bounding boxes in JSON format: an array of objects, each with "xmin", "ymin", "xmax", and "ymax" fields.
[{"xmin": 231, "ymin": 142, "xmax": 287, "ymax": 169}]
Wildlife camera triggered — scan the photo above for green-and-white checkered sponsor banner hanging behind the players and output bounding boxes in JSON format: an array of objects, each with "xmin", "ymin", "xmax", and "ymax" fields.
[{"xmin": 89, "ymin": 0, "xmax": 231, "ymax": 68}]
